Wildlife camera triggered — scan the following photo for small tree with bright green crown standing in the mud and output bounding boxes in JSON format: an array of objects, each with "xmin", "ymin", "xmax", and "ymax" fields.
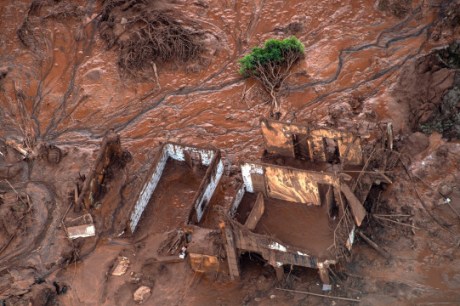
[{"xmin": 239, "ymin": 36, "xmax": 305, "ymax": 113}]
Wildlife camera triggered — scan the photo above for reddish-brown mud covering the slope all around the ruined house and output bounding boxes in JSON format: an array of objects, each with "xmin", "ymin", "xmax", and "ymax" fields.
[{"xmin": 0, "ymin": 0, "xmax": 460, "ymax": 305}]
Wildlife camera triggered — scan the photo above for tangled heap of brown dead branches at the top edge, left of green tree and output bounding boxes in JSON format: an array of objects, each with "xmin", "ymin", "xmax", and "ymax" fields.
[{"xmin": 99, "ymin": 0, "xmax": 204, "ymax": 78}]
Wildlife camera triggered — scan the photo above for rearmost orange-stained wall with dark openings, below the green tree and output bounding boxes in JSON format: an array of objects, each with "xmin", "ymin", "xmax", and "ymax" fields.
[{"xmin": 261, "ymin": 119, "xmax": 363, "ymax": 165}]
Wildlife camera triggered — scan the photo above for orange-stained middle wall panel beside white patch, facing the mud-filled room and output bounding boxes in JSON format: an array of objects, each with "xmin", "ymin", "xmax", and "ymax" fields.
[{"xmin": 265, "ymin": 166, "xmax": 321, "ymax": 205}]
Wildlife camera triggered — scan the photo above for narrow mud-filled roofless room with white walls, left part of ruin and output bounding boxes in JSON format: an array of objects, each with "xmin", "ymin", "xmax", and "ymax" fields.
[{"xmin": 129, "ymin": 143, "xmax": 224, "ymax": 233}]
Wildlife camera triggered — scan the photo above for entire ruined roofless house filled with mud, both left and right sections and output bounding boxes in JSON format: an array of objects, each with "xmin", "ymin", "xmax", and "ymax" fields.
[{"xmin": 129, "ymin": 119, "xmax": 391, "ymax": 288}]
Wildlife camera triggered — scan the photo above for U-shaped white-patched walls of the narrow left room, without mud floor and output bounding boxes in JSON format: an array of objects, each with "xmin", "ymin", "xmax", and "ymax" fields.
[{"xmin": 129, "ymin": 143, "xmax": 224, "ymax": 232}]
